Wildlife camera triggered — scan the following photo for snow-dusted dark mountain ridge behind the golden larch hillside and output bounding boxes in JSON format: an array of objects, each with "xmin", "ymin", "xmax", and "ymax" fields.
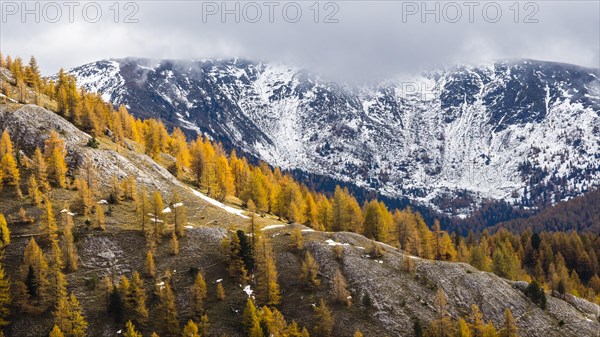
[{"xmin": 69, "ymin": 59, "xmax": 600, "ymax": 213}]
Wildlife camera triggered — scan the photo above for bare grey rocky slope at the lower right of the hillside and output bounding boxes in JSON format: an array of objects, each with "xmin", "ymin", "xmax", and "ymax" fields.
[{"xmin": 306, "ymin": 233, "xmax": 600, "ymax": 337}]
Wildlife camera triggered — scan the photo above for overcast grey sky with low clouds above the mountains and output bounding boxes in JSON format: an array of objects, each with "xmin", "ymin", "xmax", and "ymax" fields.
[{"xmin": 0, "ymin": 0, "xmax": 600, "ymax": 80}]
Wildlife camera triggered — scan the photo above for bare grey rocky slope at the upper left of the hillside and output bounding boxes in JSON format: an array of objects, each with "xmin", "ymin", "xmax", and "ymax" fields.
[{"xmin": 0, "ymin": 105, "xmax": 180, "ymax": 193}]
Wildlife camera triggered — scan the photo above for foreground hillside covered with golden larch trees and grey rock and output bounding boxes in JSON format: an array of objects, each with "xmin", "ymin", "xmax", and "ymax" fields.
[{"xmin": 0, "ymin": 56, "xmax": 600, "ymax": 337}]
